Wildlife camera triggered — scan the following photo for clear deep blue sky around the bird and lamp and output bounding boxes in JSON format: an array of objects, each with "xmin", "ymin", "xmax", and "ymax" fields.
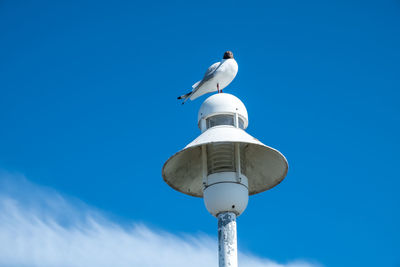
[{"xmin": 0, "ymin": 0, "xmax": 400, "ymax": 266}]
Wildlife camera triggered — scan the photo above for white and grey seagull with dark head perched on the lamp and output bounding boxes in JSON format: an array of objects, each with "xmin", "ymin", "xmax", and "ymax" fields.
[{"xmin": 178, "ymin": 51, "xmax": 238, "ymax": 104}]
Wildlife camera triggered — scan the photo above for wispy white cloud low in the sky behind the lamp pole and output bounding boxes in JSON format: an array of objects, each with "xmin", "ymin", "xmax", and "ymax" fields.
[{"xmin": 0, "ymin": 172, "xmax": 317, "ymax": 267}]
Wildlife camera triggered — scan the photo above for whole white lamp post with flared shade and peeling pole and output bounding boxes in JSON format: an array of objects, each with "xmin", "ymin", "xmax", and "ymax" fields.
[{"xmin": 162, "ymin": 93, "xmax": 288, "ymax": 267}]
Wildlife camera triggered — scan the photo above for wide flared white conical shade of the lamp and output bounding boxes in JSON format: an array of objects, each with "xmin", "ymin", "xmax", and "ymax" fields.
[{"xmin": 162, "ymin": 126, "xmax": 288, "ymax": 197}]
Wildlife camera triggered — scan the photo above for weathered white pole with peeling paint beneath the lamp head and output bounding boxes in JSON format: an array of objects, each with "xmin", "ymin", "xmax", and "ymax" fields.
[{"xmin": 218, "ymin": 212, "xmax": 238, "ymax": 267}]
